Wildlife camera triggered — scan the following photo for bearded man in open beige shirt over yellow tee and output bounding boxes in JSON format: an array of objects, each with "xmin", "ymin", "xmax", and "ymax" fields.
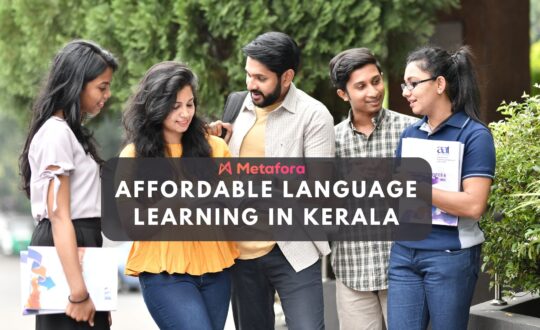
[{"xmin": 214, "ymin": 32, "xmax": 335, "ymax": 330}]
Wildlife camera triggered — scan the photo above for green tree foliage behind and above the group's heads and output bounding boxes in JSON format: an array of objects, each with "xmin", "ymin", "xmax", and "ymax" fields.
[{"xmin": 0, "ymin": 0, "xmax": 459, "ymax": 121}]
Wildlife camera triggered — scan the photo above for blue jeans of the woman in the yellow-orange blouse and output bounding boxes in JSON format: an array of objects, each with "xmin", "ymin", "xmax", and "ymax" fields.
[{"xmin": 139, "ymin": 269, "xmax": 231, "ymax": 330}]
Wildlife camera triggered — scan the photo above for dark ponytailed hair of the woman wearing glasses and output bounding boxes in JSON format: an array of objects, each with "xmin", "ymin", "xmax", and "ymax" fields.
[{"xmin": 407, "ymin": 46, "xmax": 482, "ymax": 123}]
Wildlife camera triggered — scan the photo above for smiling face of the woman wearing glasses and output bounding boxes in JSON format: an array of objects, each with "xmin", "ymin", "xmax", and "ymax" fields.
[{"xmin": 402, "ymin": 61, "xmax": 445, "ymax": 116}]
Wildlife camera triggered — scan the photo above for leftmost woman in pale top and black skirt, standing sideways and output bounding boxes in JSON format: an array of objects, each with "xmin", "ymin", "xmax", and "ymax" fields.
[{"xmin": 20, "ymin": 40, "xmax": 117, "ymax": 330}]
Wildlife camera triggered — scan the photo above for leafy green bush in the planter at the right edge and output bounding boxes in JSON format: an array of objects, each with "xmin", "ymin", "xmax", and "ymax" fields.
[{"xmin": 481, "ymin": 89, "xmax": 540, "ymax": 294}]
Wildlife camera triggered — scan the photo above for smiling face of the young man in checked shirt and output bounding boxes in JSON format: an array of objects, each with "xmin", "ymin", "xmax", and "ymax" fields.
[{"xmin": 337, "ymin": 64, "xmax": 384, "ymax": 116}]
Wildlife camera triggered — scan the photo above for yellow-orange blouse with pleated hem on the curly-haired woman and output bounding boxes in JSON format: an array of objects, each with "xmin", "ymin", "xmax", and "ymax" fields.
[{"xmin": 120, "ymin": 135, "xmax": 239, "ymax": 276}]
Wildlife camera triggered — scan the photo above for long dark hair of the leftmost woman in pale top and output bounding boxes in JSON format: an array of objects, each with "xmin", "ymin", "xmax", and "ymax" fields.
[{"xmin": 19, "ymin": 40, "xmax": 118, "ymax": 197}]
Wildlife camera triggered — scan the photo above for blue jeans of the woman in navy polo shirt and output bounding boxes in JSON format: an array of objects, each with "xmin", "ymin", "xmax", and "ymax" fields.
[{"xmin": 388, "ymin": 243, "xmax": 481, "ymax": 330}]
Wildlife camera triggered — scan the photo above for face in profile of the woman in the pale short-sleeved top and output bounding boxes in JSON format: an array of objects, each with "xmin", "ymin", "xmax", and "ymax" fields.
[{"xmin": 80, "ymin": 68, "xmax": 113, "ymax": 116}]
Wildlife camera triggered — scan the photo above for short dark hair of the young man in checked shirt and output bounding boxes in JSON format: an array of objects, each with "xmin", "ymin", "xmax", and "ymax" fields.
[{"xmin": 328, "ymin": 48, "xmax": 382, "ymax": 91}]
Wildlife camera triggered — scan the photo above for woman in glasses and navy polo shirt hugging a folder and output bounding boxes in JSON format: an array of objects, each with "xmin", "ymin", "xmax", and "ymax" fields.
[{"xmin": 388, "ymin": 47, "xmax": 495, "ymax": 330}]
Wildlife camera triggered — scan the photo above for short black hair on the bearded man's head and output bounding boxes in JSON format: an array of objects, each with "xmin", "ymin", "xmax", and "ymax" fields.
[{"xmin": 242, "ymin": 32, "xmax": 300, "ymax": 77}]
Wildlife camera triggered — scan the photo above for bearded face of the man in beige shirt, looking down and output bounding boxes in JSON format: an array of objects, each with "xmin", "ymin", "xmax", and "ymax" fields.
[{"xmin": 245, "ymin": 56, "xmax": 288, "ymax": 108}]
